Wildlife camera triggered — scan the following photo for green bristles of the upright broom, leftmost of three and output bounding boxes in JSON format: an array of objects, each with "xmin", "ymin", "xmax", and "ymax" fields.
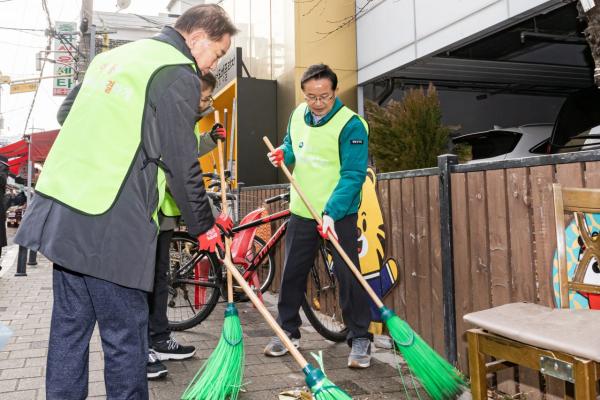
[{"xmin": 181, "ymin": 303, "xmax": 244, "ymax": 400}]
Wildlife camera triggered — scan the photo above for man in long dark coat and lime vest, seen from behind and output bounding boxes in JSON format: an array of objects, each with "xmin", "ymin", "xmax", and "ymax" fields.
[{"xmin": 15, "ymin": 4, "xmax": 237, "ymax": 400}]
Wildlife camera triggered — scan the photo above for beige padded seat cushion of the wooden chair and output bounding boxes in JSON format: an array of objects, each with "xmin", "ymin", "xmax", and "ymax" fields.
[{"xmin": 463, "ymin": 303, "xmax": 600, "ymax": 362}]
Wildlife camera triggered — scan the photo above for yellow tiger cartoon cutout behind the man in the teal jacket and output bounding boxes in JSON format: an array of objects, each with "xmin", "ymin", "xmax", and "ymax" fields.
[{"xmin": 357, "ymin": 167, "xmax": 398, "ymax": 333}]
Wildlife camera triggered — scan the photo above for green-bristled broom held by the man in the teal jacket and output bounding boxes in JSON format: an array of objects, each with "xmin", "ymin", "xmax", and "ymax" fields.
[{"xmin": 263, "ymin": 136, "xmax": 467, "ymax": 400}]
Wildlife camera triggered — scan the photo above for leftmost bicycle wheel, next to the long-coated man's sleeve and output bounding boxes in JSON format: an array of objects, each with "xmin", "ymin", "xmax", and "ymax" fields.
[{"xmin": 167, "ymin": 232, "xmax": 220, "ymax": 331}]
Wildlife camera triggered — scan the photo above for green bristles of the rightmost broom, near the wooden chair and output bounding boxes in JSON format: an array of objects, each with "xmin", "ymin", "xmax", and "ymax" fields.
[{"xmin": 380, "ymin": 307, "xmax": 467, "ymax": 400}]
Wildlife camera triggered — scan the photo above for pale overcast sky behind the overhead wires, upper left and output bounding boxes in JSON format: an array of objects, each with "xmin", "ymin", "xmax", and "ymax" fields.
[{"xmin": 0, "ymin": 0, "xmax": 168, "ymax": 141}]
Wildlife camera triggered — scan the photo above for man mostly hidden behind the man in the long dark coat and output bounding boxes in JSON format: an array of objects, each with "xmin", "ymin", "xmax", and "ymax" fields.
[{"xmin": 146, "ymin": 72, "xmax": 226, "ymax": 379}]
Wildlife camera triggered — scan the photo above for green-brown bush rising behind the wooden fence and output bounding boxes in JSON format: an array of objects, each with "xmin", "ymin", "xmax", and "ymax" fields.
[{"xmin": 365, "ymin": 84, "xmax": 451, "ymax": 172}]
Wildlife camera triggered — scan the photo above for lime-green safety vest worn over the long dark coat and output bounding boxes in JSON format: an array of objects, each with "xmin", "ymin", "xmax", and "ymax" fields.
[{"xmin": 36, "ymin": 39, "xmax": 195, "ymax": 219}]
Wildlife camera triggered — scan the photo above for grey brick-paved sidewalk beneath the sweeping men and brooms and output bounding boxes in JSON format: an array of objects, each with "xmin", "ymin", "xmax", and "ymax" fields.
[{"xmin": 0, "ymin": 246, "xmax": 425, "ymax": 400}]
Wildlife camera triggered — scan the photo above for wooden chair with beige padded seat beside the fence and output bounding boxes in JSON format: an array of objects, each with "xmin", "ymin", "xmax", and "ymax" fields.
[{"xmin": 464, "ymin": 184, "xmax": 600, "ymax": 400}]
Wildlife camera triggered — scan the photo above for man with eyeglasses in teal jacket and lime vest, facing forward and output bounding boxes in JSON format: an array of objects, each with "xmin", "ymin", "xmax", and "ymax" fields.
[{"xmin": 264, "ymin": 64, "xmax": 372, "ymax": 368}]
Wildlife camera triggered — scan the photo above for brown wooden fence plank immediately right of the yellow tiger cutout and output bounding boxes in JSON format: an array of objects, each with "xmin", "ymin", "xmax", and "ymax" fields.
[{"xmin": 386, "ymin": 179, "xmax": 406, "ymax": 319}]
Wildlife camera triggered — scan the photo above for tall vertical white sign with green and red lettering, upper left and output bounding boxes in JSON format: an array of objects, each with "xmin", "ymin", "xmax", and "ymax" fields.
[{"xmin": 52, "ymin": 21, "xmax": 77, "ymax": 96}]
